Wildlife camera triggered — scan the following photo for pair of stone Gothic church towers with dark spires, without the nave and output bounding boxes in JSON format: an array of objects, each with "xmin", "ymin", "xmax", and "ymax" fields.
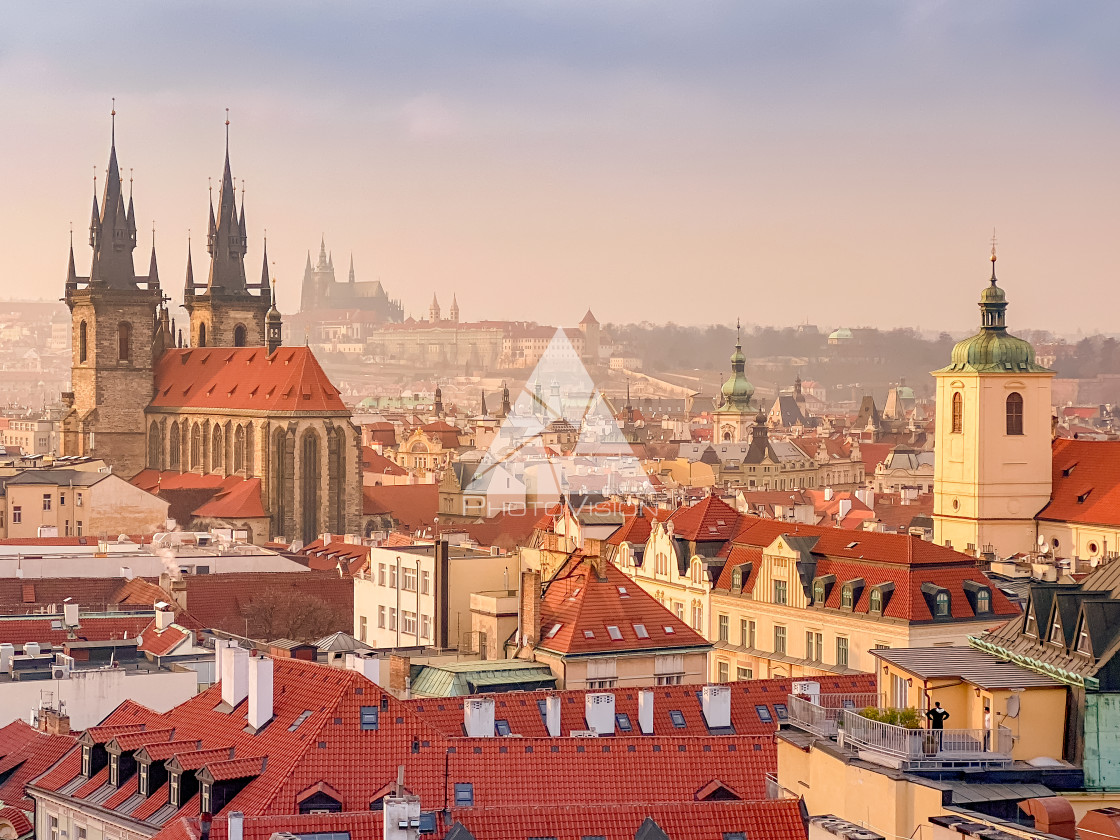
[{"xmin": 62, "ymin": 110, "xmax": 282, "ymax": 476}]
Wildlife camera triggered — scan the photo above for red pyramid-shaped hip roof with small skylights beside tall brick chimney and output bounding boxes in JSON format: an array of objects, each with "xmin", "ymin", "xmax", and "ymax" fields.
[{"xmin": 538, "ymin": 557, "xmax": 710, "ymax": 656}]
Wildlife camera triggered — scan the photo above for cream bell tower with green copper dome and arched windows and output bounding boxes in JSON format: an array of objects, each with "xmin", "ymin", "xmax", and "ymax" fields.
[{"xmin": 933, "ymin": 248, "xmax": 1054, "ymax": 557}]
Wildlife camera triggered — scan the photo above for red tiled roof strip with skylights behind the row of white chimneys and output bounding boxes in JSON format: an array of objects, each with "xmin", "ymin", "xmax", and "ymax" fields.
[{"xmin": 405, "ymin": 674, "xmax": 875, "ymax": 738}]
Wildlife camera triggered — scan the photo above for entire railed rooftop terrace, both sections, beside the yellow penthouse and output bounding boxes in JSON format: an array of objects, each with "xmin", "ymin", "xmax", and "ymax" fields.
[{"xmin": 786, "ymin": 694, "xmax": 1012, "ymax": 769}]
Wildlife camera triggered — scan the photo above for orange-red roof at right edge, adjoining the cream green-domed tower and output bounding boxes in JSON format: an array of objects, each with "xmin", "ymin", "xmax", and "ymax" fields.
[{"xmin": 1037, "ymin": 438, "xmax": 1120, "ymax": 526}]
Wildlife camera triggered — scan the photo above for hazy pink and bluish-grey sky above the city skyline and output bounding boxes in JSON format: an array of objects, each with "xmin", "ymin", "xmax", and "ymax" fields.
[{"xmin": 0, "ymin": 0, "xmax": 1120, "ymax": 332}]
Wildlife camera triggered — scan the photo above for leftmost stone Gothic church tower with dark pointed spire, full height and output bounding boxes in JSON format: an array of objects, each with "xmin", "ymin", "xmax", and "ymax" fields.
[{"xmin": 60, "ymin": 106, "xmax": 170, "ymax": 477}]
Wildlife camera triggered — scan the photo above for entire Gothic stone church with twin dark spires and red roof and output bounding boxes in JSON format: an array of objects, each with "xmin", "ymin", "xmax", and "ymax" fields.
[{"xmin": 62, "ymin": 112, "xmax": 362, "ymax": 543}]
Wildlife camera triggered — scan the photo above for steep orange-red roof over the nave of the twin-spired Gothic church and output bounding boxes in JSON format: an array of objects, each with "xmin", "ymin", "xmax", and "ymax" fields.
[{"xmin": 150, "ymin": 347, "xmax": 349, "ymax": 416}]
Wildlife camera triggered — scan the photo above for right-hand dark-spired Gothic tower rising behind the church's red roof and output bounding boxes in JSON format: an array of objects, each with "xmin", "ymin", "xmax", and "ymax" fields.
[{"xmin": 183, "ymin": 110, "xmax": 272, "ymax": 347}]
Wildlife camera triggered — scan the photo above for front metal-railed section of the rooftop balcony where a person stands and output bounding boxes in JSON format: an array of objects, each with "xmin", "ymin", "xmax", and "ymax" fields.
[{"xmin": 840, "ymin": 709, "xmax": 1012, "ymax": 769}]
